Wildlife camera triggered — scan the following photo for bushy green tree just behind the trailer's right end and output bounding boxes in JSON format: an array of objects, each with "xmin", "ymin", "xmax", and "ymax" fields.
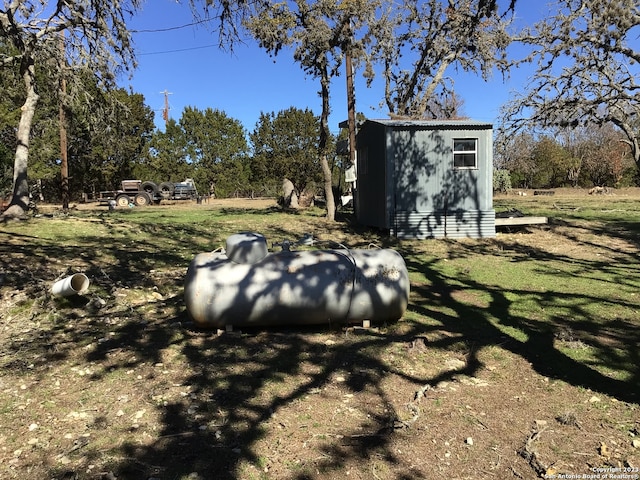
[{"xmin": 180, "ymin": 107, "xmax": 250, "ymax": 197}]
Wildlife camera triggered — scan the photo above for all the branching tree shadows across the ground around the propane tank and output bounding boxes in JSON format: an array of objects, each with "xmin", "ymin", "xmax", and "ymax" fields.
[{"xmin": 3, "ymin": 214, "xmax": 640, "ymax": 480}]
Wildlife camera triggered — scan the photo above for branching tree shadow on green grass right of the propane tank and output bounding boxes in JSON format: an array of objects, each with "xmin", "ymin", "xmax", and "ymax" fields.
[{"xmin": 409, "ymin": 227, "xmax": 640, "ymax": 403}]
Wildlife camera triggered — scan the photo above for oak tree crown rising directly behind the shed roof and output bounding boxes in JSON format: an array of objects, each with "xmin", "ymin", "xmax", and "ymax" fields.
[{"xmin": 370, "ymin": 0, "xmax": 515, "ymax": 119}]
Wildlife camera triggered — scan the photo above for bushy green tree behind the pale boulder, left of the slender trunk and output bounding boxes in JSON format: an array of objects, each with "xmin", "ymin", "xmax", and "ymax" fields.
[{"xmin": 249, "ymin": 107, "xmax": 322, "ymax": 194}]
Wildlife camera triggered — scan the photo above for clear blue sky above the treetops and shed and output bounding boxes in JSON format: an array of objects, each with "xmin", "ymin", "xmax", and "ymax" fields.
[{"xmin": 120, "ymin": 0, "xmax": 546, "ymax": 132}]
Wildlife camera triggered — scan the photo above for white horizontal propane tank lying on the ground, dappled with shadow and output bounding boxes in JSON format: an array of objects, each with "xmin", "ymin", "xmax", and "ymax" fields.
[{"xmin": 184, "ymin": 233, "xmax": 409, "ymax": 328}]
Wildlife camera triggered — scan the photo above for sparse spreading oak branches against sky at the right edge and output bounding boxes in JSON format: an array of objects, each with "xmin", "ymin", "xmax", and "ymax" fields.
[{"xmin": 503, "ymin": 0, "xmax": 640, "ymax": 169}]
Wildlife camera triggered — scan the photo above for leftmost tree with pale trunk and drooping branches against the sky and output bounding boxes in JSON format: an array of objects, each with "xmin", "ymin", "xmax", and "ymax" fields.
[{"xmin": 0, "ymin": 0, "xmax": 141, "ymax": 217}]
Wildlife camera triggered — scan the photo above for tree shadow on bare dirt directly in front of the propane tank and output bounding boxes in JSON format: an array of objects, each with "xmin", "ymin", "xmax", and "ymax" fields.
[{"xmin": 84, "ymin": 327, "xmax": 450, "ymax": 479}]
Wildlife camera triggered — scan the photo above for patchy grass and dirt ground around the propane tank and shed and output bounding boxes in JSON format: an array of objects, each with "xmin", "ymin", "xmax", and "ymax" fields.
[{"xmin": 0, "ymin": 190, "xmax": 640, "ymax": 480}]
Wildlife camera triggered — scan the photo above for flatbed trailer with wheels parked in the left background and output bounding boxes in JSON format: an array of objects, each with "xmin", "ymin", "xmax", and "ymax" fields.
[{"xmin": 97, "ymin": 178, "xmax": 198, "ymax": 207}]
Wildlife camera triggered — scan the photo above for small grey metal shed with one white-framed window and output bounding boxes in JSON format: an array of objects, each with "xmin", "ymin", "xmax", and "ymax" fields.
[{"xmin": 354, "ymin": 120, "xmax": 495, "ymax": 239}]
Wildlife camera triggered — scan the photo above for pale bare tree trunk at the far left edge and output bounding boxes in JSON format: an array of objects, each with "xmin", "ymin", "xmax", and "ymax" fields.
[{"xmin": 2, "ymin": 55, "xmax": 39, "ymax": 218}]
